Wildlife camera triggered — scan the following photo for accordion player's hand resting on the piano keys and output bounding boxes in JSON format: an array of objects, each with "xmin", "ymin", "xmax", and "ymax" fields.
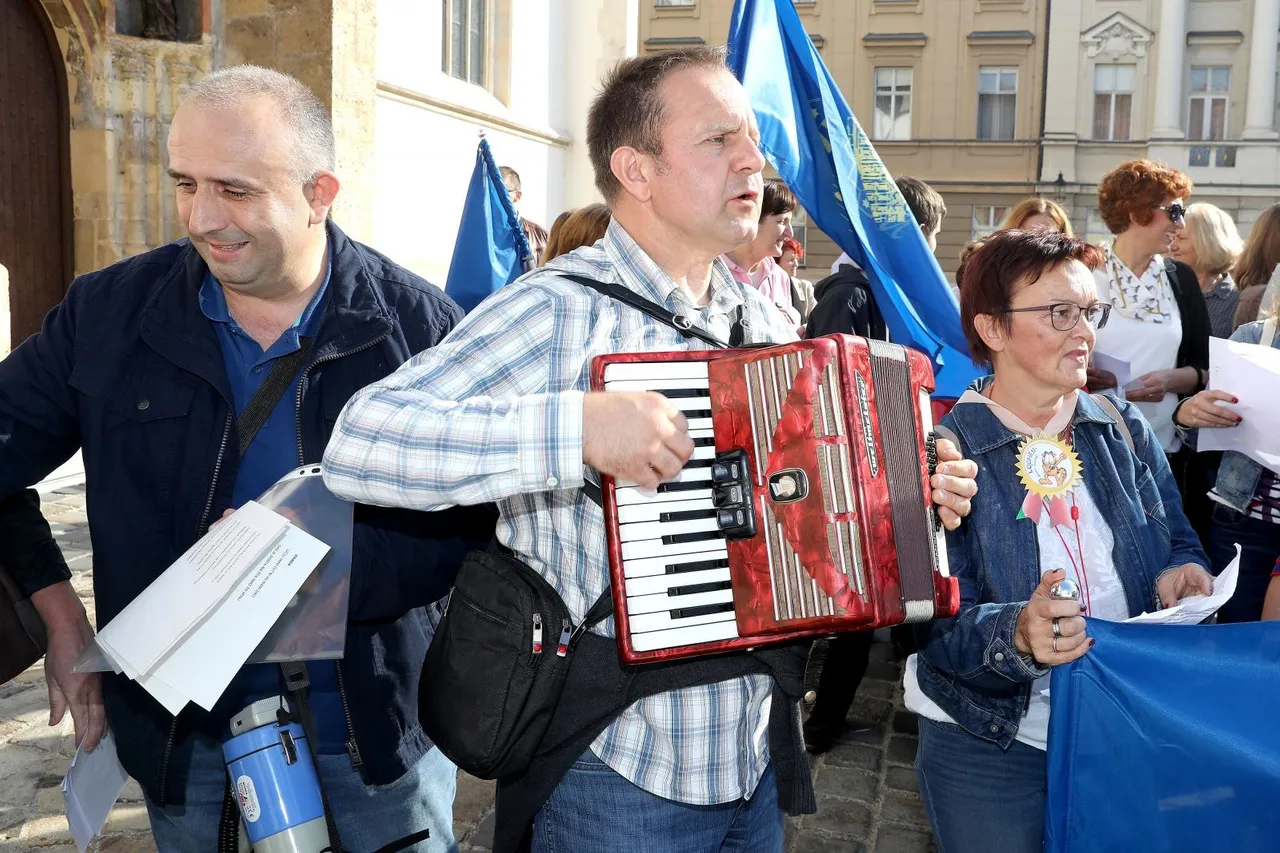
[{"xmin": 582, "ymin": 391, "xmax": 694, "ymax": 489}]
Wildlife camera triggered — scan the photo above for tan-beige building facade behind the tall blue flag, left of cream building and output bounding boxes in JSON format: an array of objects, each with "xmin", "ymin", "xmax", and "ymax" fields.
[{"xmin": 640, "ymin": 0, "xmax": 1059, "ymax": 278}]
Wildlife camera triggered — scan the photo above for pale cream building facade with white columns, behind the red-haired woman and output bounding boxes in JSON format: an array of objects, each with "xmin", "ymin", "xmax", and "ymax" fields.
[{"xmin": 1039, "ymin": 0, "xmax": 1280, "ymax": 240}]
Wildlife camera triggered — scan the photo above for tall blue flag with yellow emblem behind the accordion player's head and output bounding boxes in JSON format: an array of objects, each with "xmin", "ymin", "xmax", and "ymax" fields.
[{"xmin": 728, "ymin": 0, "xmax": 986, "ymax": 397}]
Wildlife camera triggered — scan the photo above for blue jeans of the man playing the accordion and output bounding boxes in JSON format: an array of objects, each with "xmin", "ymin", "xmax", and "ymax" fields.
[{"xmin": 532, "ymin": 751, "xmax": 782, "ymax": 853}]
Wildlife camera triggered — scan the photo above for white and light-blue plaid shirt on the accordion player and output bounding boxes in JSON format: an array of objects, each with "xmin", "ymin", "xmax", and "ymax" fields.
[{"xmin": 324, "ymin": 222, "xmax": 796, "ymax": 804}]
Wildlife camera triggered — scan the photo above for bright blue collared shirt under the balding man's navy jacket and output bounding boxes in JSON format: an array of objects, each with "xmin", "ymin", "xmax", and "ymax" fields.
[{"xmin": 200, "ymin": 259, "xmax": 347, "ymax": 754}]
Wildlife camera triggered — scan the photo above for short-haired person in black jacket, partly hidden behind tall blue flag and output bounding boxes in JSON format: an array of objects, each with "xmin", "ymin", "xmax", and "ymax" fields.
[{"xmin": 804, "ymin": 175, "xmax": 947, "ymax": 754}]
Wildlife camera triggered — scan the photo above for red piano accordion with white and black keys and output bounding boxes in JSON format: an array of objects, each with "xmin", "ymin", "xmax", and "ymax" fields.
[{"xmin": 591, "ymin": 334, "xmax": 960, "ymax": 663}]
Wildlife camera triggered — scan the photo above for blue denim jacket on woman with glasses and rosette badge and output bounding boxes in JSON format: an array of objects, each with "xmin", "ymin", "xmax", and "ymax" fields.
[{"xmin": 916, "ymin": 393, "xmax": 1208, "ymax": 749}]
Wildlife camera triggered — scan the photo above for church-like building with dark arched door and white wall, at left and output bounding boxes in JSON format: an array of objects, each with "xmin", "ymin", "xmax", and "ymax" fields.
[{"xmin": 0, "ymin": 0, "xmax": 640, "ymax": 355}]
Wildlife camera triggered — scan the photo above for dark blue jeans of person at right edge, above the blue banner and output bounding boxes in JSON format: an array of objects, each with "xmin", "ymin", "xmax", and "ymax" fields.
[{"xmin": 1208, "ymin": 505, "xmax": 1280, "ymax": 622}]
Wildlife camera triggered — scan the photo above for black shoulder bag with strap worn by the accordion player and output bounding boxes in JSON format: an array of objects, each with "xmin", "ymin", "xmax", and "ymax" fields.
[{"xmin": 417, "ymin": 274, "xmax": 745, "ymax": 779}]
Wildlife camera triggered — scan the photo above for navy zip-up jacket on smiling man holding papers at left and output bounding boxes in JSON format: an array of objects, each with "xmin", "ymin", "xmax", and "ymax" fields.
[{"xmin": 0, "ymin": 223, "xmax": 494, "ymax": 804}]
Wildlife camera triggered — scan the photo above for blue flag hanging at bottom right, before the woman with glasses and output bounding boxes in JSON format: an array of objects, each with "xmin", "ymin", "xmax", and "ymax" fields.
[{"xmin": 1044, "ymin": 619, "xmax": 1280, "ymax": 853}]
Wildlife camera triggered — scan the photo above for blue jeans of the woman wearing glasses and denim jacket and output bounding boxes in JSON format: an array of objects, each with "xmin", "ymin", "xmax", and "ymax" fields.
[{"xmin": 915, "ymin": 717, "xmax": 1046, "ymax": 853}]
